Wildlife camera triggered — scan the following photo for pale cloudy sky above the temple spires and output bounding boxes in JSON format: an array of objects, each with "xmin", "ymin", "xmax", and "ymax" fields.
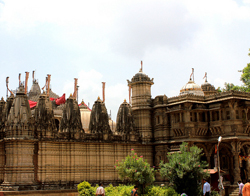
[{"xmin": 0, "ymin": 0, "xmax": 250, "ymax": 120}]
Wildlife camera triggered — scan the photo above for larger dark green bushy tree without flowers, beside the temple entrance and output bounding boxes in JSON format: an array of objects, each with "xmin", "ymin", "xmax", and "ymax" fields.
[{"xmin": 159, "ymin": 142, "xmax": 209, "ymax": 195}]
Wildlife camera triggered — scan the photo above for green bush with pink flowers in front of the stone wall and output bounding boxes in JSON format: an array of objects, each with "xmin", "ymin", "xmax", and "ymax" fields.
[{"xmin": 115, "ymin": 149, "xmax": 155, "ymax": 193}]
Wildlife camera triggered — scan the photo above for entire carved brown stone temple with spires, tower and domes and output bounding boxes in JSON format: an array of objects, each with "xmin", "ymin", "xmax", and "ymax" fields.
[{"xmin": 0, "ymin": 69, "xmax": 250, "ymax": 194}]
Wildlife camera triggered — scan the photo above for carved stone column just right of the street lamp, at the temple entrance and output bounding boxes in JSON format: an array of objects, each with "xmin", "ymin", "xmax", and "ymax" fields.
[{"xmin": 231, "ymin": 141, "xmax": 241, "ymax": 184}]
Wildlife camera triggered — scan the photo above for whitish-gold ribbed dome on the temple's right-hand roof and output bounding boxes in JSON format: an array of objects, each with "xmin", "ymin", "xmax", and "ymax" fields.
[{"xmin": 180, "ymin": 78, "xmax": 204, "ymax": 96}]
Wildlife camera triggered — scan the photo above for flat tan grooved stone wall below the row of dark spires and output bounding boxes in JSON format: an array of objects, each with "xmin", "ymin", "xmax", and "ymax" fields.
[{"xmin": 35, "ymin": 141, "xmax": 153, "ymax": 184}]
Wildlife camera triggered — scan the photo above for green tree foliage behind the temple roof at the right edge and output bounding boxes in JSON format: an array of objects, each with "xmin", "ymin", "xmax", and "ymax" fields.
[{"xmin": 221, "ymin": 49, "xmax": 250, "ymax": 92}]
